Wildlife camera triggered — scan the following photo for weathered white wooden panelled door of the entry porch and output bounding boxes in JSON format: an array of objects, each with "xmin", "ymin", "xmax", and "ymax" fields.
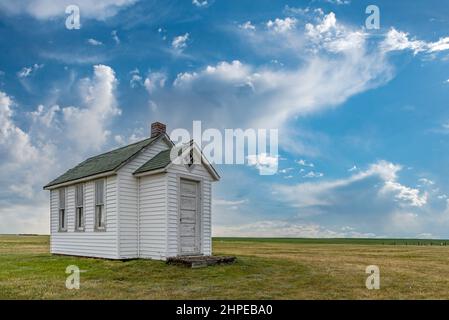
[{"xmin": 179, "ymin": 179, "xmax": 200, "ymax": 255}]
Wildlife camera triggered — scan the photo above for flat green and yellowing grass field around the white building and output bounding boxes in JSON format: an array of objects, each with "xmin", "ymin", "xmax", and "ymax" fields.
[{"xmin": 0, "ymin": 236, "xmax": 449, "ymax": 299}]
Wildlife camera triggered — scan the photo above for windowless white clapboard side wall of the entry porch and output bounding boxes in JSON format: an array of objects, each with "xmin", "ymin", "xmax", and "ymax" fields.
[{"xmin": 139, "ymin": 174, "xmax": 167, "ymax": 260}]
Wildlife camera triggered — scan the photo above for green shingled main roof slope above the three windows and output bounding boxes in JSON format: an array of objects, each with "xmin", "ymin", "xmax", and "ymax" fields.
[{"xmin": 44, "ymin": 136, "xmax": 159, "ymax": 188}]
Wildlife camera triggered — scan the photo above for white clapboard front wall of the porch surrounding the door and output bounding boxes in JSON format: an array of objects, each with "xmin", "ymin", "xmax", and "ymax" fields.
[{"xmin": 167, "ymin": 165, "xmax": 212, "ymax": 256}]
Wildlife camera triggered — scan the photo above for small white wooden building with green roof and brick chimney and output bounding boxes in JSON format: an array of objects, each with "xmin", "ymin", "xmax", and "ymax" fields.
[{"xmin": 44, "ymin": 122, "xmax": 220, "ymax": 260}]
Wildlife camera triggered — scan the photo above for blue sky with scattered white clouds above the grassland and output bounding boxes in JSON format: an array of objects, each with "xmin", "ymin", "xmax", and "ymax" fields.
[{"xmin": 0, "ymin": 0, "xmax": 449, "ymax": 238}]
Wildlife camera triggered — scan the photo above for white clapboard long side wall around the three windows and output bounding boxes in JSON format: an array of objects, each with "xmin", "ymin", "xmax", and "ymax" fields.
[{"xmin": 50, "ymin": 176, "xmax": 119, "ymax": 259}]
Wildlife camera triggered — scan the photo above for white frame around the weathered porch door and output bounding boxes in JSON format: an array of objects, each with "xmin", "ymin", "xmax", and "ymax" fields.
[{"xmin": 177, "ymin": 174, "xmax": 204, "ymax": 256}]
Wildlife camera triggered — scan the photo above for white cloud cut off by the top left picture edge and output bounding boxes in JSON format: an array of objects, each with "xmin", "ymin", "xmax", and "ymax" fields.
[{"xmin": 0, "ymin": 0, "xmax": 137, "ymax": 20}]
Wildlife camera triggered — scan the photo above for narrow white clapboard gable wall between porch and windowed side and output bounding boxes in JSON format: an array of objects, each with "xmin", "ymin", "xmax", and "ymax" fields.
[{"xmin": 117, "ymin": 139, "xmax": 168, "ymax": 259}]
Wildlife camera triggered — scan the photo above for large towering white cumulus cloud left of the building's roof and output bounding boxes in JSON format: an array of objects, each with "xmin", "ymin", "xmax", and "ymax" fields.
[{"xmin": 0, "ymin": 65, "xmax": 120, "ymax": 233}]
